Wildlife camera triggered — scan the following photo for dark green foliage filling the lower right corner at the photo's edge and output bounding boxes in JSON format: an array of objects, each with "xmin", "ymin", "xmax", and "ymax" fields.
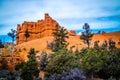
[{"xmin": 99, "ymin": 48, "xmax": 120, "ymax": 80}]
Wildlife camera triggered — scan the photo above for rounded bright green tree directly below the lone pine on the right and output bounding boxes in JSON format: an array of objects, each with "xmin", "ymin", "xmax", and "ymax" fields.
[{"xmin": 81, "ymin": 48, "xmax": 103, "ymax": 79}]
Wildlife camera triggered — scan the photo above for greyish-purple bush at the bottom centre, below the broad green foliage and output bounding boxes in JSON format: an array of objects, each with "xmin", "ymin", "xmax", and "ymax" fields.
[{"xmin": 47, "ymin": 68, "xmax": 86, "ymax": 80}]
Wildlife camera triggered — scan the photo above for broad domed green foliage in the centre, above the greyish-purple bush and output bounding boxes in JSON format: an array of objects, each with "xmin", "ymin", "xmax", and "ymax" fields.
[{"xmin": 45, "ymin": 49, "xmax": 80, "ymax": 77}]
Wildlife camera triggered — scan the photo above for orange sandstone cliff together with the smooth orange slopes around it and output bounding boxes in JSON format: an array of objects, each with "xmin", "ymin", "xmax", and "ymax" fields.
[{"xmin": 15, "ymin": 14, "xmax": 120, "ymax": 60}]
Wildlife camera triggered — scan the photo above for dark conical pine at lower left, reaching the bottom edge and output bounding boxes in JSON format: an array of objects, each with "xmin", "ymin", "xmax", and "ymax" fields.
[{"xmin": 21, "ymin": 48, "xmax": 39, "ymax": 80}]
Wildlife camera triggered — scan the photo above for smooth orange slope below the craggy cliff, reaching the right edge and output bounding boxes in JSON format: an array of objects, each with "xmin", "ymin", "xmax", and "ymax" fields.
[{"xmin": 16, "ymin": 32, "xmax": 120, "ymax": 58}]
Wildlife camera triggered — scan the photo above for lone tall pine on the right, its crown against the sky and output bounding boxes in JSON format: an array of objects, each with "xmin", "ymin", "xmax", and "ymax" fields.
[{"xmin": 80, "ymin": 23, "xmax": 93, "ymax": 48}]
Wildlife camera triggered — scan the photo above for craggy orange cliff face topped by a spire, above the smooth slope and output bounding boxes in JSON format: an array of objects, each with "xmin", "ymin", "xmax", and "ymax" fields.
[{"xmin": 16, "ymin": 13, "xmax": 60, "ymax": 44}]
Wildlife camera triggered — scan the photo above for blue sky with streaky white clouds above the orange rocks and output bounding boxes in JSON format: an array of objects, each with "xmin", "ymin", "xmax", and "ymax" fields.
[{"xmin": 0, "ymin": 0, "xmax": 120, "ymax": 35}]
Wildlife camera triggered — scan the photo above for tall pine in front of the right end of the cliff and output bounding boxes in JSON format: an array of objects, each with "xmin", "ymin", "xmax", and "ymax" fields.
[{"xmin": 53, "ymin": 25, "xmax": 68, "ymax": 52}]
